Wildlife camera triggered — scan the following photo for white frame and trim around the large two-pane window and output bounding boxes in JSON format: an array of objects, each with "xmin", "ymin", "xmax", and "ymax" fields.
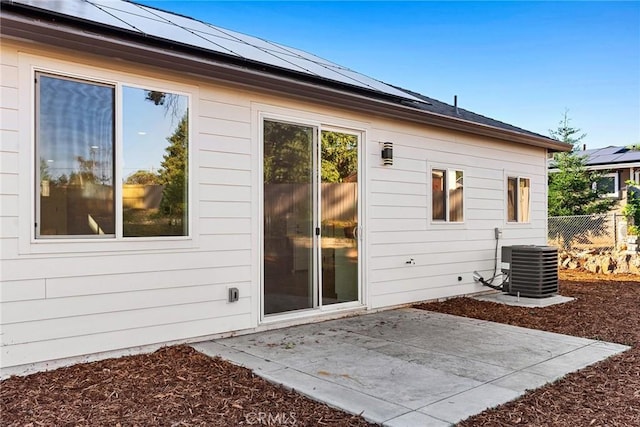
[{"xmin": 18, "ymin": 53, "xmax": 199, "ymax": 254}]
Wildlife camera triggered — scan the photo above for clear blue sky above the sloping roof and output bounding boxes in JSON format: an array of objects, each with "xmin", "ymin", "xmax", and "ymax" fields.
[{"xmin": 138, "ymin": 0, "xmax": 640, "ymax": 148}]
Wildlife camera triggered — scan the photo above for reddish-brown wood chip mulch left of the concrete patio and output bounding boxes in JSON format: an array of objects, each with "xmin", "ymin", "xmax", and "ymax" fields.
[{"xmin": 0, "ymin": 346, "xmax": 370, "ymax": 427}]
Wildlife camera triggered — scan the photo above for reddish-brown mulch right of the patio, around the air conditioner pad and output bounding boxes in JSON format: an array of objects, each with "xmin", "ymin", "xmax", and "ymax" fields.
[{"xmin": 418, "ymin": 271, "xmax": 640, "ymax": 427}]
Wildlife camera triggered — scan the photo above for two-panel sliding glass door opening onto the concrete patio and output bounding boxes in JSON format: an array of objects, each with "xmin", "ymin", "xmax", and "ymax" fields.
[{"xmin": 263, "ymin": 120, "xmax": 360, "ymax": 315}]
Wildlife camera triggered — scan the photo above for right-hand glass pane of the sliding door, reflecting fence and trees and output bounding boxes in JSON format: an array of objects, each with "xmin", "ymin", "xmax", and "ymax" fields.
[{"xmin": 320, "ymin": 131, "xmax": 358, "ymax": 305}]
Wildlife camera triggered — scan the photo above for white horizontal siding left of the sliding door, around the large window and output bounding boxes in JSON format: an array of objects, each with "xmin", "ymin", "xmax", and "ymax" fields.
[{"xmin": 0, "ymin": 46, "xmax": 257, "ymax": 367}]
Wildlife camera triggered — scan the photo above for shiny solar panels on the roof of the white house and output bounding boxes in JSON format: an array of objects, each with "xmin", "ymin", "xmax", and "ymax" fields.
[{"xmin": 13, "ymin": 0, "xmax": 420, "ymax": 101}]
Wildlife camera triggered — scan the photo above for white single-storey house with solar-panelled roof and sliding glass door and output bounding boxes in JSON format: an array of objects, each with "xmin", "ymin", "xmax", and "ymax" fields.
[{"xmin": 0, "ymin": 0, "xmax": 570, "ymax": 375}]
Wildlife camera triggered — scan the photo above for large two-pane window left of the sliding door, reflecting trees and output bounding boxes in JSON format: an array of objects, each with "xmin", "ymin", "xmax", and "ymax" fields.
[{"xmin": 35, "ymin": 72, "xmax": 189, "ymax": 238}]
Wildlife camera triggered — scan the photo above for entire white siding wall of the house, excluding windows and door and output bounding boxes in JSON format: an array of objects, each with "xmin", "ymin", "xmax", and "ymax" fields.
[{"xmin": 0, "ymin": 43, "xmax": 546, "ymax": 369}]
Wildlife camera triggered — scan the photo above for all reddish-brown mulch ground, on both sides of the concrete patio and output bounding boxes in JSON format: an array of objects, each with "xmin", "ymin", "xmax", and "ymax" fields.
[{"xmin": 0, "ymin": 272, "xmax": 640, "ymax": 427}]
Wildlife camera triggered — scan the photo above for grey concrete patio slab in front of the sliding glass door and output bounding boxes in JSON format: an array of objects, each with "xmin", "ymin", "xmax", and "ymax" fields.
[{"xmin": 193, "ymin": 308, "xmax": 629, "ymax": 427}]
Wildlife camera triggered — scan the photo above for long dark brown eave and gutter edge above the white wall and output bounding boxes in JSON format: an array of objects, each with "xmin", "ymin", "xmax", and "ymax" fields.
[{"xmin": 0, "ymin": 7, "xmax": 572, "ymax": 152}]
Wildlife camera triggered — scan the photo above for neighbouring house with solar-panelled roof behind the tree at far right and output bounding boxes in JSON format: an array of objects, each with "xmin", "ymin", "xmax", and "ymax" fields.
[{"xmin": 549, "ymin": 146, "xmax": 640, "ymax": 211}]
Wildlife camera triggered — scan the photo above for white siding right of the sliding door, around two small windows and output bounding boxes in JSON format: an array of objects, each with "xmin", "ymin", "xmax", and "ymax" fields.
[{"xmin": 368, "ymin": 123, "xmax": 546, "ymax": 308}]
